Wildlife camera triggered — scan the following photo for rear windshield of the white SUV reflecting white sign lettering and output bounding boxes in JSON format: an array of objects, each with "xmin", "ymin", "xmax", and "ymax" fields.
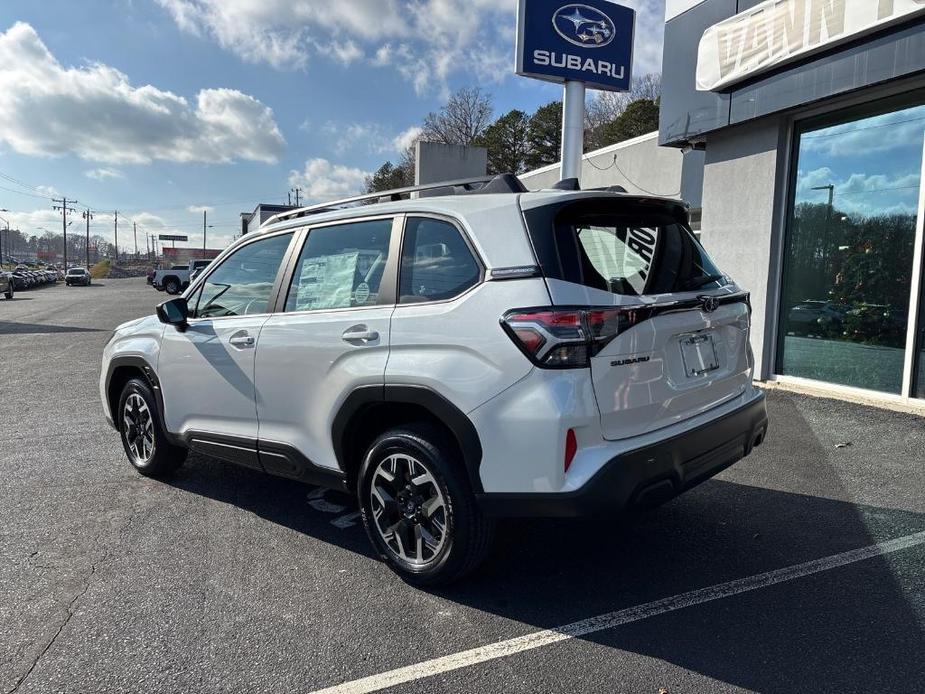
[{"xmin": 527, "ymin": 198, "xmax": 726, "ymax": 296}]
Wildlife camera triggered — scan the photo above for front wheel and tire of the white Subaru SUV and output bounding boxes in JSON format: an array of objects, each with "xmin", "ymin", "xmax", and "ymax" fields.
[{"xmin": 113, "ymin": 378, "xmax": 187, "ymax": 477}]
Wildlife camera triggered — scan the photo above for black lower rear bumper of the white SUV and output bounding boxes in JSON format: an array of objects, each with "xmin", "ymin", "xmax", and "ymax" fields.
[{"xmin": 478, "ymin": 393, "xmax": 768, "ymax": 517}]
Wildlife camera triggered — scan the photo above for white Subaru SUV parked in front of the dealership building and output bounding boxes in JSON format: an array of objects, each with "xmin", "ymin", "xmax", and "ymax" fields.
[{"xmin": 100, "ymin": 175, "xmax": 768, "ymax": 585}]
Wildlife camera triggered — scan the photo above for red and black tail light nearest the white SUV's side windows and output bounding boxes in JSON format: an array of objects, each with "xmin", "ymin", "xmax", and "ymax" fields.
[{"xmin": 501, "ymin": 307, "xmax": 647, "ymax": 369}]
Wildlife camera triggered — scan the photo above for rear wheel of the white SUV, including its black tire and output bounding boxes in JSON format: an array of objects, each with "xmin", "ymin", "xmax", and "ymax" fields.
[{"xmin": 357, "ymin": 424, "xmax": 494, "ymax": 586}]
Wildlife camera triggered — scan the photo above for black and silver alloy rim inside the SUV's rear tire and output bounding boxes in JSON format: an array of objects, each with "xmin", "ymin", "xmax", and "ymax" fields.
[{"xmin": 369, "ymin": 454, "xmax": 447, "ymax": 567}]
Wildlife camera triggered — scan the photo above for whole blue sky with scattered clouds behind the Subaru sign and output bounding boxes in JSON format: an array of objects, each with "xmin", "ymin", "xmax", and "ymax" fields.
[{"xmin": 0, "ymin": 0, "xmax": 664, "ymax": 246}]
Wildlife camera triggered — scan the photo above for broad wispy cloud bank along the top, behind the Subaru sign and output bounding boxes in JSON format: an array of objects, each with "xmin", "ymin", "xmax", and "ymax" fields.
[{"xmin": 157, "ymin": 0, "xmax": 665, "ymax": 93}]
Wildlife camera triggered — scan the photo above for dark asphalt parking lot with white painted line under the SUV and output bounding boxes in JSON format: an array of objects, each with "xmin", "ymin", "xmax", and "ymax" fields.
[{"xmin": 0, "ymin": 280, "xmax": 925, "ymax": 694}]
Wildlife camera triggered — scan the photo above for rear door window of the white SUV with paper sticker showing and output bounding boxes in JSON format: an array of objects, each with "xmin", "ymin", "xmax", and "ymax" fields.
[{"xmin": 286, "ymin": 219, "xmax": 392, "ymax": 311}]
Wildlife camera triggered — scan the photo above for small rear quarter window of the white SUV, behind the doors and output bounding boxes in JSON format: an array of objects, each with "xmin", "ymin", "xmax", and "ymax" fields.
[{"xmin": 399, "ymin": 217, "xmax": 482, "ymax": 304}]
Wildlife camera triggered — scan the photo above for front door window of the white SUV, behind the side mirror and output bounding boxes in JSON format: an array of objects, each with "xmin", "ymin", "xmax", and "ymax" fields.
[{"xmin": 192, "ymin": 233, "xmax": 292, "ymax": 318}]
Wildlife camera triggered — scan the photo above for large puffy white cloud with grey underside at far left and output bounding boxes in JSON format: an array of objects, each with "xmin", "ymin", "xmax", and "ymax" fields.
[{"xmin": 0, "ymin": 22, "xmax": 285, "ymax": 164}]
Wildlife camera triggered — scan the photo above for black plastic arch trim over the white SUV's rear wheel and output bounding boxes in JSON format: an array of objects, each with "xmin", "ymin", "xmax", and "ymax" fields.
[{"xmin": 331, "ymin": 384, "xmax": 483, "ymax": 494}]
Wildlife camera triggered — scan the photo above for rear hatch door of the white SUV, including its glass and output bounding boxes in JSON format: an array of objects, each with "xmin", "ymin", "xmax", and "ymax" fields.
[{"xmin": 525, "ymin": 195, "xmax": 751, "ymax": 440}]
